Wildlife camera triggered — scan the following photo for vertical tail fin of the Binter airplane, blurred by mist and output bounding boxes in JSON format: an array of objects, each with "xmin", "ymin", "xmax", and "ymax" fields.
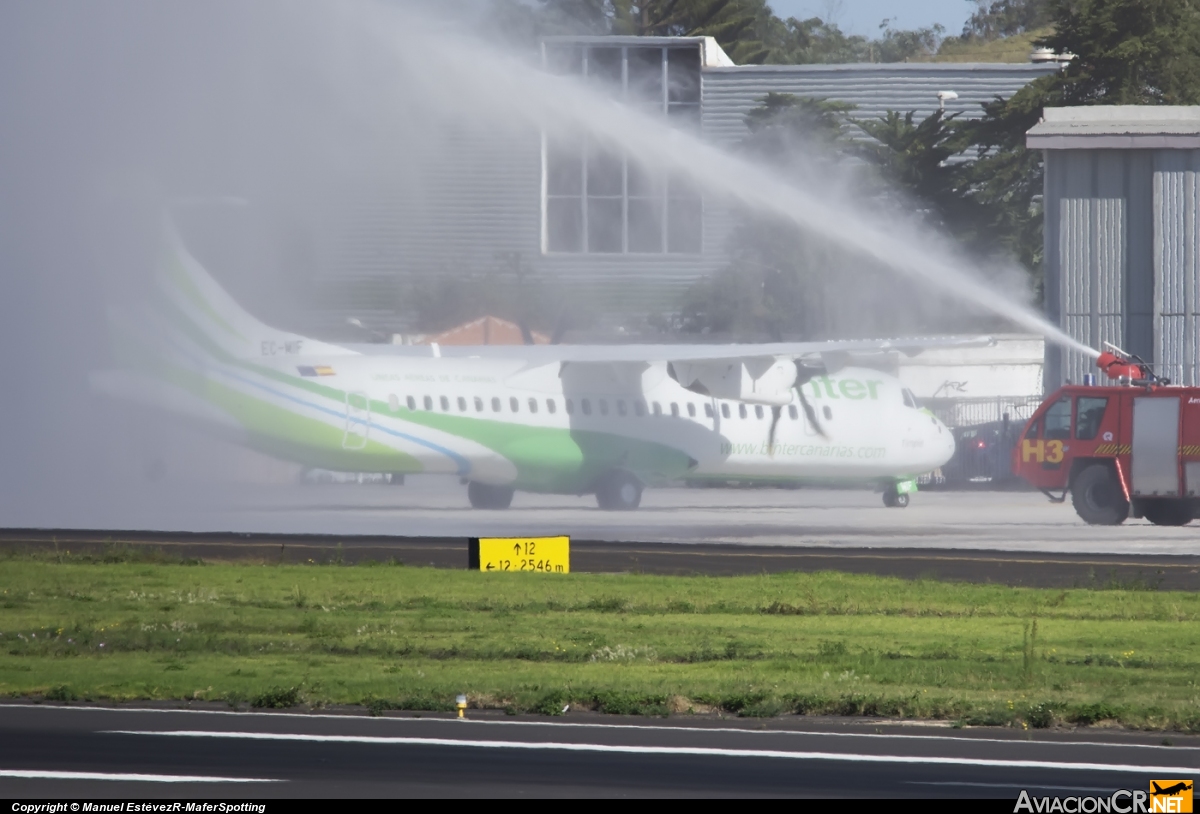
[{"xmin": 156, "ymin": 219, "xmax": 355, "ymax": 358}]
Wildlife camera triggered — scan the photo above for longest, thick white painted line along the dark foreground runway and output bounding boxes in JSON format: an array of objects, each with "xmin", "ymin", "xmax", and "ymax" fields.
[{"xmin": 109, "ymin": 730, "xmax": 1195, "ymax": 777}]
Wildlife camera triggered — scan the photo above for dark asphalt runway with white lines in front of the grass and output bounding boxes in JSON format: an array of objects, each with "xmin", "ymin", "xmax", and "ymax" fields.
[{"xmin": 0, "ymin": 705, "xmax": 1200, "ymax": 802}]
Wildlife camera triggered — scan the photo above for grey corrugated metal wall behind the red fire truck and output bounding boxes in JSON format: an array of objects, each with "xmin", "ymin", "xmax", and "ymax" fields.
[{"xmin": 1045, "ymin": 150, "xmax": 1200, "ymax": 388}]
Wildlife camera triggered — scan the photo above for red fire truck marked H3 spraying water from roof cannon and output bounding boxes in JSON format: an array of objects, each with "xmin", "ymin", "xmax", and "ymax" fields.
[{"xmin": 1013, "ymin": 349, "xmax": 1200, "ymax": 526}]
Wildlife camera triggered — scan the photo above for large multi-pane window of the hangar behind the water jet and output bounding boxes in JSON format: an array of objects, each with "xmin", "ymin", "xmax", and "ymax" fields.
[{"xmin": 544, "ymin": 43, "xmax": 703, "ymax": 255}]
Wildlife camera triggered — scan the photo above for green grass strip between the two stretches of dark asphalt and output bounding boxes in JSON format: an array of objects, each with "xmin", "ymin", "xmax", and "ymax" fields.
[{"xmin": 0, "ymin": 551, "xmax": 1200, "ymax": 731}]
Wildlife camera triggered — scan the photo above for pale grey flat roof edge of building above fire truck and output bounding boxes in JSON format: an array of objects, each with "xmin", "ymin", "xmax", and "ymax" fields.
[{"xmin": 1025, "ymin": 104, "xmax": 1200, "ymax": 150}]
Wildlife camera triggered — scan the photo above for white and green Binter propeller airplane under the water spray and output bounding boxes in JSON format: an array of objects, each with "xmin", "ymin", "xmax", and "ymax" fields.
[{"xmin": 91, "ymin": 219, "xmax": 964, "ymax": 510}]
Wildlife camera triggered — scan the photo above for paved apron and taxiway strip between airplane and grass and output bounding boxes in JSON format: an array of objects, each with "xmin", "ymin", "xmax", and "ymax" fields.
[{"xmin": 0, "ymin": 478, "xmax": 1200, "ymax": 591}]
